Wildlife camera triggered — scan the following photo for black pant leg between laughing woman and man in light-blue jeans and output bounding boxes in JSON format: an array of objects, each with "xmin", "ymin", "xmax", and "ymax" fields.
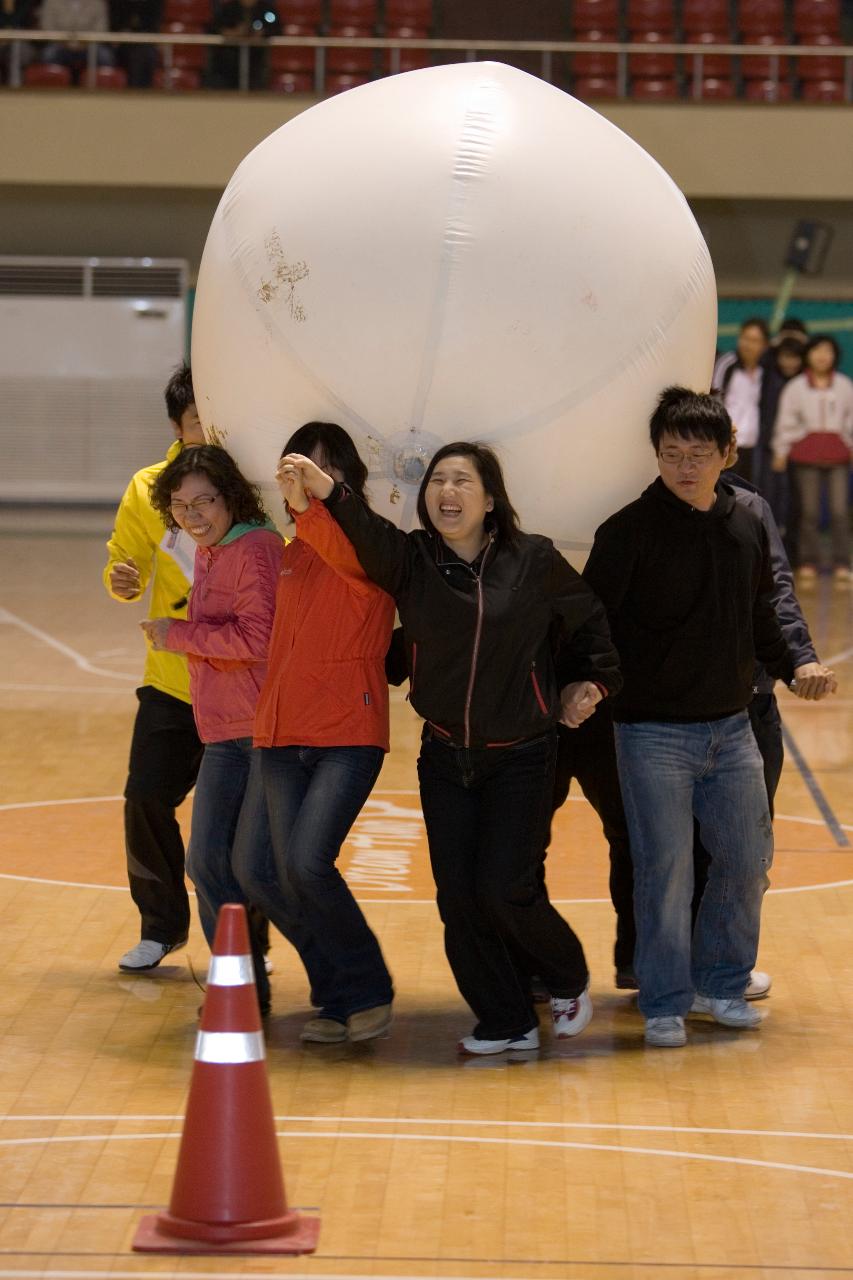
[{"xmin": 548, "ymin": 701, "xmax": 637, "ymax": 969}]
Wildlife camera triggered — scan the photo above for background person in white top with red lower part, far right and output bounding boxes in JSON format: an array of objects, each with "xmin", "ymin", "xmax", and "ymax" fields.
[{"xmin": 772, "ymin": 334, "xmax": 853, "ymax": 584}]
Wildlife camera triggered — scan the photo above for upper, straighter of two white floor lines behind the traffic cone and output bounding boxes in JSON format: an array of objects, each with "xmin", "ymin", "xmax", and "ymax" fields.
[{"xmin": 0, "ymin": 1112, "xmax": 853, "ymax": 1142}]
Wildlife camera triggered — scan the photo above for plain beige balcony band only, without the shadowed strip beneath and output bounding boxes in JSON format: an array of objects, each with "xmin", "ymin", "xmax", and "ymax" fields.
[{"xmin": 0, "ymin": 91, "xmax": 853, "ymax": 200}]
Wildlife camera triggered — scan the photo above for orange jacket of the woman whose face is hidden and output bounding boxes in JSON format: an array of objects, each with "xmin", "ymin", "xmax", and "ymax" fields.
[{"xmin": 255, "ymin": 499, "xmax": 394, "ymax": 751}]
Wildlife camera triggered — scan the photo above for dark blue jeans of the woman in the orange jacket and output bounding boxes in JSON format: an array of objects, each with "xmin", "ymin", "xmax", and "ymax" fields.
[{"xmin": 249, "ymin": 746, "xmax": 393, "ymax": 1021}]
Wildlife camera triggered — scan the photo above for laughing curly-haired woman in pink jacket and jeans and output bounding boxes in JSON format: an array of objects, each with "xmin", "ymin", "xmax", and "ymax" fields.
[{"xmin": 141, "ymin": 444, "xmax": 283, "ymax": 1012}]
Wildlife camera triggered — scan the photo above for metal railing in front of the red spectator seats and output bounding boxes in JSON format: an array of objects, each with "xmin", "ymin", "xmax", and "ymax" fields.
[{"xmin": 0, "ymin": 28, "xmax": 853, "ymax": 104}]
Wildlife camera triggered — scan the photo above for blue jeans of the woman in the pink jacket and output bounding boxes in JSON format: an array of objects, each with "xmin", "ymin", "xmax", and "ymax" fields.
[{"xmin": 187, "ymin": 737, "xmax": 269, "ymax": 1007}]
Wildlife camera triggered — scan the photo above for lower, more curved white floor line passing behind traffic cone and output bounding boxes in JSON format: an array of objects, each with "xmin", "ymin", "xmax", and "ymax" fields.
[{"xmin": 0, "ymin": 1129, "xmax": 853, "ymax": 1181}]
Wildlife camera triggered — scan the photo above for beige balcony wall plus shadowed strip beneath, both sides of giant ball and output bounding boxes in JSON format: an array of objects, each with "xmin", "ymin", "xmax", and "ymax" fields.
[{"xmin": 0, "ymin": 91, "xmax": 853, "ymax": 298}]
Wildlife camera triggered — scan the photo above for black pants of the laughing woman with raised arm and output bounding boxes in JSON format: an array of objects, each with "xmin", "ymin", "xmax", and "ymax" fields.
[{"xmin": 418, "ymin": 728, "xmax": 589, "ymax": 1039}]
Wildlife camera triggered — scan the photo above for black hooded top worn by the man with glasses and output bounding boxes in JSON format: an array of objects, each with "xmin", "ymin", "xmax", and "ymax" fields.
[{"xmin": 584, "ymin": 479, "xmax": 794, "ymax": 722}]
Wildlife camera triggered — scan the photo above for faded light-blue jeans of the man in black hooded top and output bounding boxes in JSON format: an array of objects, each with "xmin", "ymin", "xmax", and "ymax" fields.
[{"xmin": 616, "ymin": 712, "xmax": 774, "ymax": 1018}]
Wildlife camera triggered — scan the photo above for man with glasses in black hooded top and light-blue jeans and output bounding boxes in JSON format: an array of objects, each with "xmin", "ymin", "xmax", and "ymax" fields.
[{"xmin": 584, "ymin": 387, "xmax": 794, "ymax": 1047}]
